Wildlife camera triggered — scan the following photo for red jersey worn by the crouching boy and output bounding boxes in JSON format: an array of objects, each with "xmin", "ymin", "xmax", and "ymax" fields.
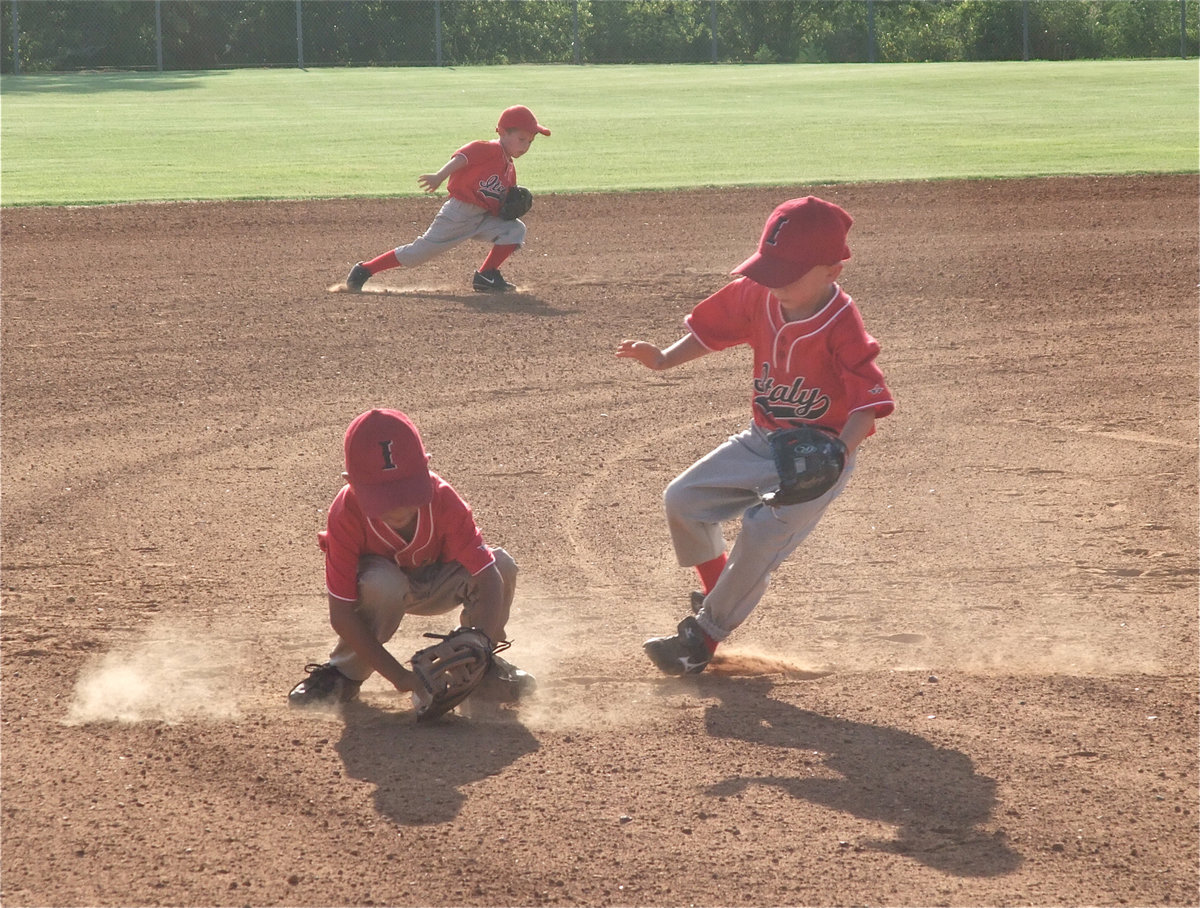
[{"xmin": 317, "ymin": 474, "xmax": 496, "ymax": 602}]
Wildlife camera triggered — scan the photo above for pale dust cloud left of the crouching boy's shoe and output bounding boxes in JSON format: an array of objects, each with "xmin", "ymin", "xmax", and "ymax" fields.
[{"xmin": 64, "ymin": 627, "xmax": 240, "ymax": 726}]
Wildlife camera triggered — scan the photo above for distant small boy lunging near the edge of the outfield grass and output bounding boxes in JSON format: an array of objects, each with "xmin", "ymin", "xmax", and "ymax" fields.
[{"xmin": 346, "ymin": 106, "xmax": 550, "ymax": 293}]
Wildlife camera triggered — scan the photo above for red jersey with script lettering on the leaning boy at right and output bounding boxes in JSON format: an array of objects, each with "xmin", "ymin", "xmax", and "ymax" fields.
[{"xmin": 686, "ymin": 277, "xmax": 895, "ymax": 432}]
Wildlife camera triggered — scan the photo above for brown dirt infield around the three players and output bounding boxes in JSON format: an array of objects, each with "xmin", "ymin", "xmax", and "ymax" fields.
[{"xmin": 0, "ymin": 175, "xmax": 1200, "ymax": 906}]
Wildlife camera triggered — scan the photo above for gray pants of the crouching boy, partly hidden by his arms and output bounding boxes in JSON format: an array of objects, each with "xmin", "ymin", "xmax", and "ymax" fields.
[{"xmin": 329, "ymin": 548, "xmax": 517, "ymax": 681}]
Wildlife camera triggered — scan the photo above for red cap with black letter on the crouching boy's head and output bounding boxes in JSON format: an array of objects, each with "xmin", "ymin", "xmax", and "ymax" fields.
[{"xmin": 346, "ymin": 409, "xmax": 433, "ymax": 517}]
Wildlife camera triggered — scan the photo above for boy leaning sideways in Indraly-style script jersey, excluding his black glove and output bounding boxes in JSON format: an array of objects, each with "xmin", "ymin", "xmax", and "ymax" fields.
[{"xmin": 617, "ymin": 196, "xmax": 894, "ymax": 675}]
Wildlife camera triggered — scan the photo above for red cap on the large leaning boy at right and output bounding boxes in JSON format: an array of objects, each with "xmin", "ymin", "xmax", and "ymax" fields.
[{"xmin": 732, "ymin": 196, "xmax": 854, "ymax": 288}]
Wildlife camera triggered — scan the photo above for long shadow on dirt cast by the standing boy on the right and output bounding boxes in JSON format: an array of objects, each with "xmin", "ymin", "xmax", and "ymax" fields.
[{"xmin": 702, "ymin": 677, "xmax": 1021, "ymax": 877}]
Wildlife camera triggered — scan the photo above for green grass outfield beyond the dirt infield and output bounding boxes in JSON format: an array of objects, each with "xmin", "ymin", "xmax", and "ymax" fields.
[{"xmin": 0, "ymin": 60, "xmax": 1200, "ymax": 205}]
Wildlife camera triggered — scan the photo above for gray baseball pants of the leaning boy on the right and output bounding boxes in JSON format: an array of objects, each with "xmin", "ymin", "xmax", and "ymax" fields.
[{"xmin": 662, "ymin": 426, "xmax": 854, "ymax": 641}]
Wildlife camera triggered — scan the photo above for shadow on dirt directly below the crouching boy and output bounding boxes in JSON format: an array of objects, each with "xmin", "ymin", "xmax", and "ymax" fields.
[{"xmin": 328, "ymin": 703, "xmax": 538, "ymax": 826}]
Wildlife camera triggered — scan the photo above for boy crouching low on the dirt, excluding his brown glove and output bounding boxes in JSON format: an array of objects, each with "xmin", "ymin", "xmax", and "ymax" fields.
[{"xmin": 288, "ymin": 409, "xmax": 534, "ymax": 706}]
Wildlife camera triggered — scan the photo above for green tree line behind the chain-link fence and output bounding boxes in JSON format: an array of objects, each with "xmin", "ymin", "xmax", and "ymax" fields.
[{"xmin": 0, "ymin": 0, "xmax": 1200, "ymax": 73}]
